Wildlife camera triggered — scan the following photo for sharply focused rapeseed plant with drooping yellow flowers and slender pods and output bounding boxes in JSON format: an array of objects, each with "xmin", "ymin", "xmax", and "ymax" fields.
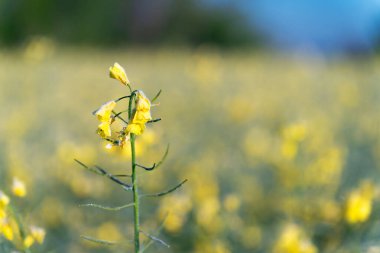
[{"xmin": 84, "ymin": 60, "xmax": 174, "ymax": 253}]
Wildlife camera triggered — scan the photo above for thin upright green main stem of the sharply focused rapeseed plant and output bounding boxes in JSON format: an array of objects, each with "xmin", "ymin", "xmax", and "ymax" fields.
[{"xmin": 128, "ymin": 92, "xmax": 140, "ymax": 253}]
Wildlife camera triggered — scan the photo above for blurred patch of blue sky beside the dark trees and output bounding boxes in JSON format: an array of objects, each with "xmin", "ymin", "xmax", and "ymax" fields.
[{"xmin": 204, "ymin": 0, "xmax": 380, "ymax": 51}]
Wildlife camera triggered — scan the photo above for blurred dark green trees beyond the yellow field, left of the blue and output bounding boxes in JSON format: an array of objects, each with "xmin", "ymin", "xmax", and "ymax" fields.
[{"xmin": 0, "ymin": 0, "xmax": 252, "ymax": 47}]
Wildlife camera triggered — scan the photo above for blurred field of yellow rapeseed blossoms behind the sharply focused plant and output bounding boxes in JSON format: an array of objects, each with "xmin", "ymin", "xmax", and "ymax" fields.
[{"xmin": 0, "ymin": 41, "xmax": 380, "ymax": 253}]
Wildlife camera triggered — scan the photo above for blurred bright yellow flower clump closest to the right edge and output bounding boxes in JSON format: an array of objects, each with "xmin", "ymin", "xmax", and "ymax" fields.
[{"xmin": 345, "ymin": 181, "xmax": 374, "ymax": 224}]
